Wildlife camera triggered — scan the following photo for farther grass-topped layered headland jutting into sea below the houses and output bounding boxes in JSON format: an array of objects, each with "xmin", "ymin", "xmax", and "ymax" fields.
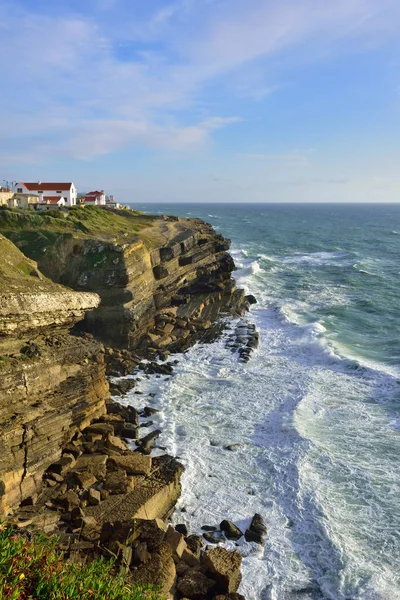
[{"xmin": 0, "ymin": 207, "xmax": 244, "ymax": 350}]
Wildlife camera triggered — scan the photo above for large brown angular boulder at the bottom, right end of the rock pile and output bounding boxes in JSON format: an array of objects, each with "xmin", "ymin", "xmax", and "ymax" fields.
[{"xmin": 203, "ymin": 546, "xmax": 242, "ymax": 593}]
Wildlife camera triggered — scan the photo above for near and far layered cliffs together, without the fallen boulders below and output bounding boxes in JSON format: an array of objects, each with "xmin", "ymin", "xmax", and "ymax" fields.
[{"xmin": 0, "ymin": 207, "xmax": 245, "ymax": 513}]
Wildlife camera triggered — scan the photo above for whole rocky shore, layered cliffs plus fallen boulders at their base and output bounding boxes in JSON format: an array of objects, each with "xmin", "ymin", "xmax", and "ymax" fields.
[{"xmin": 0, "ymin": 207, "xmax": 246, "ymax": 599}]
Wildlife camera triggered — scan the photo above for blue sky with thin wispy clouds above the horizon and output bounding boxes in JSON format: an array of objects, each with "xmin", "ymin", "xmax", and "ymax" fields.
[{"xmin": 0, "ymin": 0, "xmax": 400, "ymax": 203}]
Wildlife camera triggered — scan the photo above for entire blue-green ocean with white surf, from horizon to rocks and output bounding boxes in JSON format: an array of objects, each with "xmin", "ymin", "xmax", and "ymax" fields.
[{"xmin": 127, "ymin": 204, "xmax": 400, "ymax": 600}]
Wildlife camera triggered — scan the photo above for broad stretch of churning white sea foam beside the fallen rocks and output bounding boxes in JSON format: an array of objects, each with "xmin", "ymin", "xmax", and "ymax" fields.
[{"xmin": 122, "ymin": 309, "xmax": 400, "ymax": 600}]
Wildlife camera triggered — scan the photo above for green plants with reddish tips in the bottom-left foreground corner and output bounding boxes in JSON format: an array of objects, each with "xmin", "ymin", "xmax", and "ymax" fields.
[{"xmin": 0, "ymin": 527, "xmax": 161, "ymax": 600}]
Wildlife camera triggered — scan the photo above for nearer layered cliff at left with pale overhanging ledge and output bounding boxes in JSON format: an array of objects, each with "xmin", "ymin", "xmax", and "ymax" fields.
[{"xmin": 0, "ymin": 236, "xmax": 108, "ymax": 514}]
